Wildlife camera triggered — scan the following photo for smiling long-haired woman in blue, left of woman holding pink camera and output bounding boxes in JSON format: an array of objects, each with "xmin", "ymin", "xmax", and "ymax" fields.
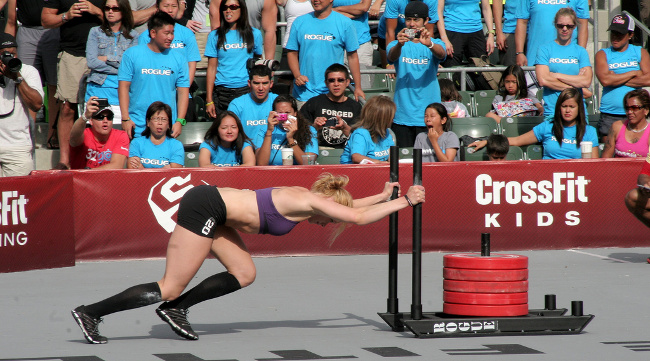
[{"xmin": 199, "ymin": 111, "xmax": 255, "ymax": 168}]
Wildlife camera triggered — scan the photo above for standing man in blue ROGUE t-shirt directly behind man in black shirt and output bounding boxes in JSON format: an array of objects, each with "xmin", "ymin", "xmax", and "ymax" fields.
[{"xmin": 286, "ymin": 0, "xmax": 366, "ymax": 102}]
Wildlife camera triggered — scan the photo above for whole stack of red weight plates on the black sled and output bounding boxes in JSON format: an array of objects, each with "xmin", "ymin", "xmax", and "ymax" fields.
[{"xmin": 443, "ymin": 253, "xmax": 528, "ymax": 317}]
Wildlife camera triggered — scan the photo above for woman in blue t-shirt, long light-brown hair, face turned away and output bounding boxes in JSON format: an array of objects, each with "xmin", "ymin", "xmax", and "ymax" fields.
[{"xmin": 341, "ymin": 95, "xmax": 395, "ymax": 164}]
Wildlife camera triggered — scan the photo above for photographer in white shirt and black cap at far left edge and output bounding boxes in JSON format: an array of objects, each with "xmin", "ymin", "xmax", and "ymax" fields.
[{"xmin": 0, "ymin": 33, "xmax": 43, "ymax": 177}]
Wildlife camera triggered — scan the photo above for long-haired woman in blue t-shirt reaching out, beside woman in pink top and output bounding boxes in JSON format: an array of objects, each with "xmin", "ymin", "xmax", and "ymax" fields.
[{"xmin": 468, "ymin": 88, "xmax": 598, "ymax": 159}]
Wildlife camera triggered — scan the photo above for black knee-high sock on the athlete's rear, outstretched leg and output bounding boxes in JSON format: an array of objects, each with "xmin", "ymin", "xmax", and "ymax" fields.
[{"xmin": 85, "ymin": 282, "xmax": 162, "ymax": 317}]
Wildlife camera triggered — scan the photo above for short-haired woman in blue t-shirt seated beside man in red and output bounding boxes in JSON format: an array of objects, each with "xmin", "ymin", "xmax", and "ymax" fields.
[{"xmin": 127, "ymin": 101, "xmax": 185, "ymax": 169}]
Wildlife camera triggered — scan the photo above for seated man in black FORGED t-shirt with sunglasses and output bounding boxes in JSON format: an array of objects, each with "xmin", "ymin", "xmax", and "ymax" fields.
[{"xmin": 300, "ymin": 63, "xmax": 361, "ymax": 149}]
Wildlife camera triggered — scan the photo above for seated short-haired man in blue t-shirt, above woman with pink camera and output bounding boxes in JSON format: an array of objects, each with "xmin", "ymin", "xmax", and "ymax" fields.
[{"xmin": 228, "ymin": 65, "xmax": 278, "ymax": 138}]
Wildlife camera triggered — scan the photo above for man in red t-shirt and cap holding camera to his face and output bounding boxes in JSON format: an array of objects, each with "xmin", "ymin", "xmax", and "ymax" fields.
[{"xmin": 70, "ymin": 97, "xmax": 129, "ymax": 169}]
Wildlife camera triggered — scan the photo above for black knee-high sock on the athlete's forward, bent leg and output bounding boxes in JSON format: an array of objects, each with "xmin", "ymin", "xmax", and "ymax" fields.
[{"xmin": 160, "ymin": 272, "xmax": 241, "ymax": 309}]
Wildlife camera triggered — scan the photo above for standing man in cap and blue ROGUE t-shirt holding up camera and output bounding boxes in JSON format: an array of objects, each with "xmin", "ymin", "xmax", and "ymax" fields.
[{"xmin": 386, "ymin": 1, "xmax": 447, "ymax": 147}]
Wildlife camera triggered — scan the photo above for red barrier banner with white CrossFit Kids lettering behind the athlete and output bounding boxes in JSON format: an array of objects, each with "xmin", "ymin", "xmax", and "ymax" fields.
[{"xmin": 30, "ymin": 159, "xmax": 650, "ymax": 260}]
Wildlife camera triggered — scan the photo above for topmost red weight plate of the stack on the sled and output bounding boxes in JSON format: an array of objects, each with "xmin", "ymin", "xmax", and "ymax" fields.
[{"xmin": 443, "ymin": 253, "xmax": 528, "ymax": 269}]
